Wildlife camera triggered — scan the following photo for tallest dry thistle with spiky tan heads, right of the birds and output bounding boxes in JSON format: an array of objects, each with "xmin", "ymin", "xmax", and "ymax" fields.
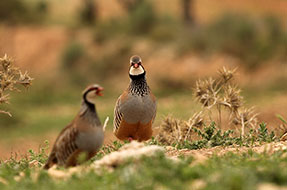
[{"xmin": 195, "ymin": 67, "xmax": 258, "ymax": 136}]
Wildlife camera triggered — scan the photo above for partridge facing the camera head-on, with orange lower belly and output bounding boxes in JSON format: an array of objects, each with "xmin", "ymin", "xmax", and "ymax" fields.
[{"xmin": 114, "ymin": 55, "xmax": 156, "ymax": 141}]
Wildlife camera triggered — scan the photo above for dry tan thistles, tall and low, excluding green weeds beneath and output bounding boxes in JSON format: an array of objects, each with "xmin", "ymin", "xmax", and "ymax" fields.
[{"xmin": 155, "ymin": 67, "xmax": 258, "ymax": 145}]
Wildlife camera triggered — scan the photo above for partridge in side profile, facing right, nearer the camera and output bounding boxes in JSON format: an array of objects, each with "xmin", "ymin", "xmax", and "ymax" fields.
[{"xmin": 44, "ymin": 84, "xmax": 104, "ymax": 169}]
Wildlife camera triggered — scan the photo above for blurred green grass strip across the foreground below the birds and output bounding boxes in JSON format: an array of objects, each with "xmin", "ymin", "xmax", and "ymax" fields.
[{"xmin": 0, "ymin": 145, "xmax": 287, "ymax": 190}]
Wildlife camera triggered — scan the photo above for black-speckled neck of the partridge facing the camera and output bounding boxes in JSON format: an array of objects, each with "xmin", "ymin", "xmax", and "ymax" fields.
[{"xmin": 129, "ymin": 73, "xmax": 149, "ymax": 96}]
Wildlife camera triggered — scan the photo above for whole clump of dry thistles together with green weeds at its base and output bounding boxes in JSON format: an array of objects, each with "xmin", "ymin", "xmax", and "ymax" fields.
[{"xmin": 153, "ymin": 68, "xmax": 277, "ymax": 149}]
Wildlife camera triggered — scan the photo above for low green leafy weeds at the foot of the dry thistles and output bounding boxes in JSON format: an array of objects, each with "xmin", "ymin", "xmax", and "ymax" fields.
[{"xmin": 155, "ymin": 122, "xmax": 279, "ymax": 150}]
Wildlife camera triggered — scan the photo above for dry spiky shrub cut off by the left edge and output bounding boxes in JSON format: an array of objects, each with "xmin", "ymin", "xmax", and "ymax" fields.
[{"xmin": 0, "ymin": 55, "xmax": 33, "ymax": 116}]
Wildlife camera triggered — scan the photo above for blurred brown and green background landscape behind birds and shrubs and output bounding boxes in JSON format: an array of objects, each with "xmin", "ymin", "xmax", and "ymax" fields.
[{"xmin": 0, "ymin": 0, "xmax": 287, "ymax": 159}]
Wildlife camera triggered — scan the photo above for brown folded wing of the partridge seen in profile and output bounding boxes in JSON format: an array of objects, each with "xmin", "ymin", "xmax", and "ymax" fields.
[{"xmin": 44, "ymin": 124, "xmax": 78, "ymax": 169}]
